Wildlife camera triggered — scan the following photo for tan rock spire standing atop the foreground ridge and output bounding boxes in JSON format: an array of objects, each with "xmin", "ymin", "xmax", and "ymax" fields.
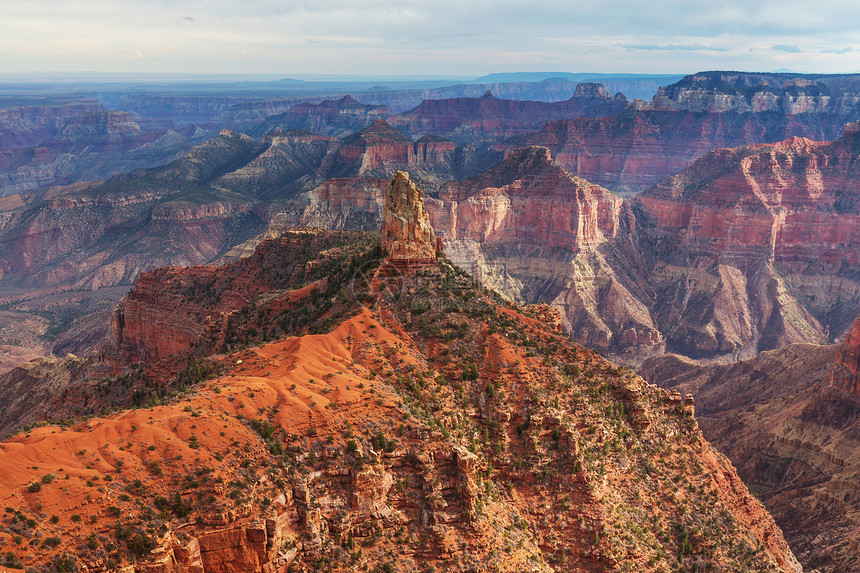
[{"xmin": 382, "ymin": 171, "xmax": 436, "ymax": 264}]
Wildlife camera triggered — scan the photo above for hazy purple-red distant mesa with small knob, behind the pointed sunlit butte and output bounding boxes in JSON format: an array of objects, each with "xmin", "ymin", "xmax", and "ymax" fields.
[{"xmin": 389, "ymin": 89, "xmax": 627, "ymax": 143}]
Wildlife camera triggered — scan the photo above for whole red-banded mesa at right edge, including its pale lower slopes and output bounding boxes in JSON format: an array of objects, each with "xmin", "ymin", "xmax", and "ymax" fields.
[{"xmin": 633, "ymin": 129, "xmax": 860, "ymax": 357}]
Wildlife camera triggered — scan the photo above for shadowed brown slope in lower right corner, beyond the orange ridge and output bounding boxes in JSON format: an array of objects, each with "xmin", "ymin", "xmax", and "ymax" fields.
[{"xmin": 642, "ymin": 328, "xmax": 860, "ymax": 573}]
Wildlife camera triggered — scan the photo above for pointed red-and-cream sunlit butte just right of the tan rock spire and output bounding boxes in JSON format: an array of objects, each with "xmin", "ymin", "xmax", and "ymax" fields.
[{"xmin": 427, "ymin": 147, "xmax": 662, "ymax": 355}]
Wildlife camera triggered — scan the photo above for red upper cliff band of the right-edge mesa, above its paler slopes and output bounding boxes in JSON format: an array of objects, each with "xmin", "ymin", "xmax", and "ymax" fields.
[{"xmin": 636, "ymin": 135, "xmax": 860, "ymax": 265}]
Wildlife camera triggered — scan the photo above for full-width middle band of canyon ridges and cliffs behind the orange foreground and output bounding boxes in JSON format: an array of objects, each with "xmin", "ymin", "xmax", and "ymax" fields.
[{"xmin": 6, "ymin": 104, "xmax": 860, "ymax": 374}]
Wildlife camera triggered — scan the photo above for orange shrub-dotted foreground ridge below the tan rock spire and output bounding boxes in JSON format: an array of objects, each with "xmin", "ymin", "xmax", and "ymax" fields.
[{"xmin": 0, "ymin": 173, "xmax": 801, "ymax": 573}]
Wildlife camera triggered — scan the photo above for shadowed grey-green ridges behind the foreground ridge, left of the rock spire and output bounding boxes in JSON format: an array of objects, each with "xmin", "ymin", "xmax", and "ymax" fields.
[{"xmin": 0, "ymin": 122, "xmax": 474, "ymax": 367}]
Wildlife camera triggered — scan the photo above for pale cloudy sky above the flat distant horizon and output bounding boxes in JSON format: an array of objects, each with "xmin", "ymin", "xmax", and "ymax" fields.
[{"xmin": 0, "ymin": 0, "xmax": 860, "ymax": 76}]
